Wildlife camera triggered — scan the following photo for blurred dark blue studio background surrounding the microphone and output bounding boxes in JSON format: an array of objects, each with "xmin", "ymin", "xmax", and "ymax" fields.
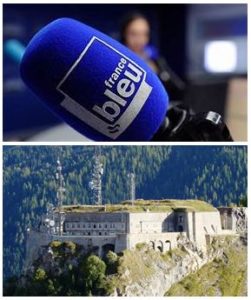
[{"xmin": 3, "ymin": 4, "xmax": 247, "ymax": 141}]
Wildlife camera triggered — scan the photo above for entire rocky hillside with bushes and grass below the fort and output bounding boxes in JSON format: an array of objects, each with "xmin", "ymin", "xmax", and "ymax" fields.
[{"xmin": 4, "ymin": 234, "xmax": 247, "ymax": 296}]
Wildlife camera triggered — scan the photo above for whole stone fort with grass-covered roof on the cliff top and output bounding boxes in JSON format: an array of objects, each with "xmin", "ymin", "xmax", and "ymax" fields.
[{"xmin": 26, "ymin": 200, "xmax": 245, "ymax": 264}]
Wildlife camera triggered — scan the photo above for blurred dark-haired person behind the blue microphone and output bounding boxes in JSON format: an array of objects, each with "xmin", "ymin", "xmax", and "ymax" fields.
[{"xmin": 120, "ymin": 12, "xmax": 185, "ymax": 101}]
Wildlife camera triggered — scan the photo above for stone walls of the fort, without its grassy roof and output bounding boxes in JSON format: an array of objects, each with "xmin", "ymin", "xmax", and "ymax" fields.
[{"xmin": 26, "ymin": 206, "xmax": 229, "ymax": 265}]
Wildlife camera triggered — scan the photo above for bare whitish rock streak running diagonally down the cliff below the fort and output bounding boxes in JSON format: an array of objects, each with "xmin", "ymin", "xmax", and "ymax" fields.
[{"xmin": 111, "ymin": 236, "xmax": 244, "ymax": 296}]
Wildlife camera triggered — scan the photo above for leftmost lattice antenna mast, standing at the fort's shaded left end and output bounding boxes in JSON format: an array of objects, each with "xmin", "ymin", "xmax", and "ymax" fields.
[{"xmin": 56, "ymin": 158, "xmax": 66, "ymax": 235}]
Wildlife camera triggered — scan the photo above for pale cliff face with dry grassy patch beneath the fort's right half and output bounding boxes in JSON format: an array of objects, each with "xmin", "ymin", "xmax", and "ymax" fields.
[{"xmin": 110, "ymin": 235, "xmax": 247, "ymax": 296}]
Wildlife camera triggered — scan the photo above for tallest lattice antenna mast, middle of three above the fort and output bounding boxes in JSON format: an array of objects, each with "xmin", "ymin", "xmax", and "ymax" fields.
[{"xmin": 89, "ymin": 146, "xmax": 104, "ymax": 205}]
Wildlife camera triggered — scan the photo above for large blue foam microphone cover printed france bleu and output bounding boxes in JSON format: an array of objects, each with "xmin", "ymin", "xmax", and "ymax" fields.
[{"xmin": 20, "ymin": 18, "xmax": 169, "ymax": 141}]
